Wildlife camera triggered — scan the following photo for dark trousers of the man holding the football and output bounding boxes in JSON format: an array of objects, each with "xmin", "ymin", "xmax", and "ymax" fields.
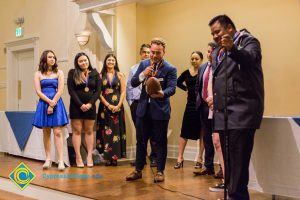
[{"xmin": 135, "ymin": 106, "xmax": 169, "ymax": 172}]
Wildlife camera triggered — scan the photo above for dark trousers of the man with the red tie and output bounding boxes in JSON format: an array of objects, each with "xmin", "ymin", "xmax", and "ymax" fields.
[{"xmin": 200, "ymin": 101, "xmax": 215, "ymax": 171}]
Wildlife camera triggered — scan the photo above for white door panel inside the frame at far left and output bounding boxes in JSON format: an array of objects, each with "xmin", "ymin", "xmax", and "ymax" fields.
[{"xmin": 16, "ymin": 49, "xmax": 36, "ymax": 111}]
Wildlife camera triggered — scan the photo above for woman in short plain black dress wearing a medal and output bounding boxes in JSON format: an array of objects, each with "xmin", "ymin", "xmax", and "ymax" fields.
[{"xmin": 68, "ymin": 52, "xmax": 101, "ymax": 167}]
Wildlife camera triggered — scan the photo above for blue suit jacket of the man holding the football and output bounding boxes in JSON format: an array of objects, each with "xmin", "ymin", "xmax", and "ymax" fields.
[{"xmin": 131, "ymin": 59, "xmax": 177, "ymax": 120}]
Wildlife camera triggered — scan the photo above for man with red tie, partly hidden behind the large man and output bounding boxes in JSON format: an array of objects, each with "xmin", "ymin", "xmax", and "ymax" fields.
[{"xmin": 194, "ymin": 43, "xmax": 216, "ymax": 175}]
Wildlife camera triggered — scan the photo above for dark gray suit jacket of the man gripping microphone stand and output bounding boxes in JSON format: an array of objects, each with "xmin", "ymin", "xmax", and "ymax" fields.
[{"xmin": 212, "ymin": 30, "xmax": 264, "ymax": 131}]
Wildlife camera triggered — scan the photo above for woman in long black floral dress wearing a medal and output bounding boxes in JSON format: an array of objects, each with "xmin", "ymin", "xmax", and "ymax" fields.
[{"xmin": 96, "ymin": 54, "xmax": 126, "ymax": 166}]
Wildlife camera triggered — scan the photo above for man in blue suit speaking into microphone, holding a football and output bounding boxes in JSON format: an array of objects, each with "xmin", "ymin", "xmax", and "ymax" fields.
[{"xmin": 126, "ymin": 38, "xmax": 177, "ymax": 182}]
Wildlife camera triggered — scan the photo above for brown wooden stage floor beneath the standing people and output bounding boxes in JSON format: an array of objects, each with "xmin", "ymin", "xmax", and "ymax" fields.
[{"xmin": 0, "ymin": 154, "xmax": 271, "ymax": 200}]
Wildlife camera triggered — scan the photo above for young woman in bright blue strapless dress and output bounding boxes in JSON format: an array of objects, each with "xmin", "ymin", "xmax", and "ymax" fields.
[{"xmin": 32, "ymin": 50, "xmax": 68, "ymax": 170}]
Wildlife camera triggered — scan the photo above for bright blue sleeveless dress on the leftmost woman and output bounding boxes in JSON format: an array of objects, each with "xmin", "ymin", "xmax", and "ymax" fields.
[{"xmin": 32, "ymin": 78, "xmax": 69, "ymax": 128}]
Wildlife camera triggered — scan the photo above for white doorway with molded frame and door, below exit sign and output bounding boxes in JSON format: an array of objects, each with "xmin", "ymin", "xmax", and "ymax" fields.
[{"xmin": 5, "ymin": 37, "xmax": 39, "ymax": 111}]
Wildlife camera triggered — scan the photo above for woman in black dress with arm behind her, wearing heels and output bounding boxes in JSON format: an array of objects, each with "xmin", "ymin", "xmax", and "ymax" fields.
[{"xmin": 174, "ymin": 51, "xmax": 204, "ymax": 169}]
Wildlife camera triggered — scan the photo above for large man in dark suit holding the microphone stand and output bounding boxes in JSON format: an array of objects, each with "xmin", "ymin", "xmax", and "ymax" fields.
[{"xmin": 209, "ymin": 15, "xmax": 264, "ymax": 200}]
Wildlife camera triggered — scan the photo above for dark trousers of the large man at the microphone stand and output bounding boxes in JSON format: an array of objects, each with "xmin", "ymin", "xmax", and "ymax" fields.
[{"xmin": 219, "ymin": 129, "xmax": 255, "ymax": 200}]
